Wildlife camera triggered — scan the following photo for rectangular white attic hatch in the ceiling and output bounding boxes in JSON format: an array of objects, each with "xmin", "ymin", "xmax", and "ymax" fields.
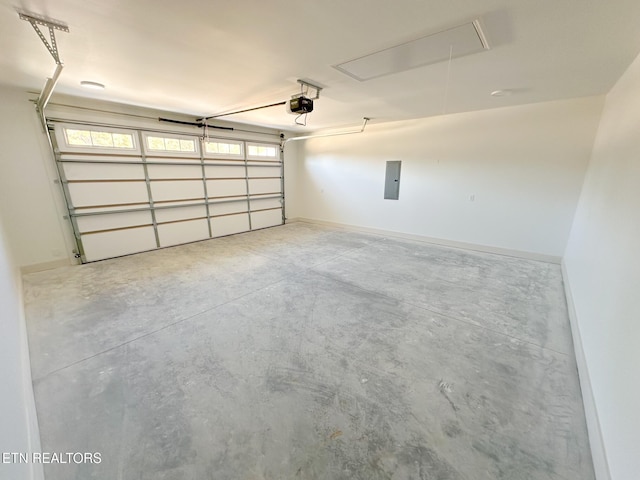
[{"xmin": 334, "ymin": 19, "xmax": 489, "ymax": 82}]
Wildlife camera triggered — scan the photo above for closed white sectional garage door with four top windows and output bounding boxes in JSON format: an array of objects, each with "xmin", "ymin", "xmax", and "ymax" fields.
[{"xmin": 53, "ymin": 122, "xmax": 284, "ymax": 263}]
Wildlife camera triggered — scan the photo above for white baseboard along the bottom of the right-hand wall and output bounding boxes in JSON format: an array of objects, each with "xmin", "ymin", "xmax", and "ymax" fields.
[{"xmin": 561, "ymin": 261, "xmax": 611, "ymax": 480}]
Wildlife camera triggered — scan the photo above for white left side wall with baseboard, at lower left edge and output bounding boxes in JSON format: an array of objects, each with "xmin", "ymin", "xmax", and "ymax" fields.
[{"xmin": 0, "ymin": 213, "xmax": 43, "ymax": 480}]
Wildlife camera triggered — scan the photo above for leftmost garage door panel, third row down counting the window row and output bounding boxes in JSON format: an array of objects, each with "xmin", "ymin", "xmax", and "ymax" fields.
[{"xmin": 68, "ymin": 182, "xmax": 149, "ymax": 207}]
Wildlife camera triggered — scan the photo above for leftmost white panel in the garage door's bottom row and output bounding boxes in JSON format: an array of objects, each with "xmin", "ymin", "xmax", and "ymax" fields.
[{"xmin": 82, "ymin": 227, "xmax": 157, "ymax": 262}]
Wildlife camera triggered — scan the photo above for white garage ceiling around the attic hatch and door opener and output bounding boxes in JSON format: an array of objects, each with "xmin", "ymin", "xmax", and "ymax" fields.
[{"xmin": 0, "ymin": 0, "xmax": 640, "ymax": 131}]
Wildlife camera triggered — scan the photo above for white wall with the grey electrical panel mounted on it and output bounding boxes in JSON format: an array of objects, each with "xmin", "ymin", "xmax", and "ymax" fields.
[{"xmin": 296, "ymin": 97, "xmax": 603, "ymax": 259}]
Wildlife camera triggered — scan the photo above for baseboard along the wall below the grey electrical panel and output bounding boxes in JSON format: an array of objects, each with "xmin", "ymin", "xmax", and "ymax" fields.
[{"xmin": 287, "ymin": 217, "xmax": 562, "ymax": 265}]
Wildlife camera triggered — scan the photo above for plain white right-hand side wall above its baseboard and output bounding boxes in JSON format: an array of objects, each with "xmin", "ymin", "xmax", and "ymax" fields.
[{"xmin": 564, "ymin": 51, "xmax": 640, "ymax": 480}]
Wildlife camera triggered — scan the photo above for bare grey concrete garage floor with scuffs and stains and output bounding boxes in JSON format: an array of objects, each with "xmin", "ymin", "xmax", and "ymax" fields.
[{"xmin": 24, "ymin": 223, "xmax": 594, "ymax": 480}]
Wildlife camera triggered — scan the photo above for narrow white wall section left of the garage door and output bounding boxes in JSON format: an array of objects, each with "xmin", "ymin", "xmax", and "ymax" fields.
[{"xmin": 0, "ymin": 87, "xmax": 73, "ymax": 267}]
